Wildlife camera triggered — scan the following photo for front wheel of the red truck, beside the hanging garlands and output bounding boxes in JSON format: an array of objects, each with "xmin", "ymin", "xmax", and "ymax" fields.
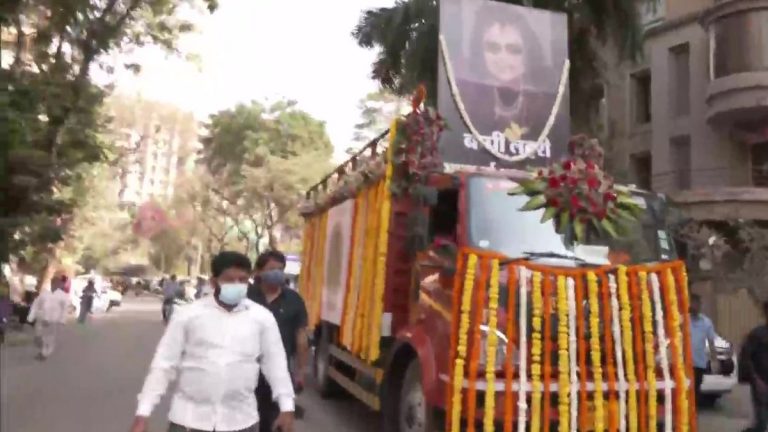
[{"xmin": 397, "ymin": 359, "xmax": 437, "ymax": 432}]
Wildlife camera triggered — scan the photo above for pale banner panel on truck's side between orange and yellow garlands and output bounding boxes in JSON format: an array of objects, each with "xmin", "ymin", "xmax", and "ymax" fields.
[{"xmin": 320, "ymin": 200, "xmax": 355, "ymax": 325}]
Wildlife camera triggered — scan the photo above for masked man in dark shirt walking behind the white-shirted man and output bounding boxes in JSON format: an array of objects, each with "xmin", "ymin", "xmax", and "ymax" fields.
[{"xmin": 248, "ymin": 250, "xmax": 309, "ymax": 432}]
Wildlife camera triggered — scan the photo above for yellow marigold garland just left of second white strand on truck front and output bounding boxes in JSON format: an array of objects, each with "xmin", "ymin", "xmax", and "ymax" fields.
[{"xmin": 557, "ymin": 275, "xmax": 571, "ymax": 432}]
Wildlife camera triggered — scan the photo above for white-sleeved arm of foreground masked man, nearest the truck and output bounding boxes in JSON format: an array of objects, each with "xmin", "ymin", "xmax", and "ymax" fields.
[{"xmin": 261, "ymin": 313, "xmax": 296, "ymax": 432}]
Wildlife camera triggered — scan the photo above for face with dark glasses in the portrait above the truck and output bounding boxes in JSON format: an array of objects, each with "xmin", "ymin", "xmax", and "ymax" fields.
[{"xmin": 483, "ymin": 23, "xmax": 525, "ymax": 83}]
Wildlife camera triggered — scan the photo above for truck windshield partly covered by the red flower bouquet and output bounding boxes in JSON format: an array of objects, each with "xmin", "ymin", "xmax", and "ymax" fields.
[{"xmin": 468, "ymin": 176, "xmax": 676, "ymax": 264}]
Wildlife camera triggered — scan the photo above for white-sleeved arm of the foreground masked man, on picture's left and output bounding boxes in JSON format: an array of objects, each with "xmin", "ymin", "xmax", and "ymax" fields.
[{"xmin": 131, "ymin": 312, "xmax": 187, "ymax": 431}]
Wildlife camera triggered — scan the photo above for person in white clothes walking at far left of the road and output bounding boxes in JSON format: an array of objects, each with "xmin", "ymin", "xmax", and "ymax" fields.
[{"xmin": 28, "ymin": 276, "xmax": 69, "ymax": 360}]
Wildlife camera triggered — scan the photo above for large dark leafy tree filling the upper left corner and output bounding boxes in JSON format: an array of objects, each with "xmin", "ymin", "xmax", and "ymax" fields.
[{"xmin": 0, "ymin": 0, "xmax": 216, "ymax": 290}]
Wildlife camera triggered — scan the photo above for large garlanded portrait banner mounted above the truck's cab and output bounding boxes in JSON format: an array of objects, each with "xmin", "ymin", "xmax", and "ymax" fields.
[{"xmin": 438, "ymin": 0, "xmax": 570, "ymax": 169}]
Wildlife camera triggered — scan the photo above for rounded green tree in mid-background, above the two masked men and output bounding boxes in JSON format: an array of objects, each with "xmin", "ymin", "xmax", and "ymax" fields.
[{"xmin": 201, "ymin": 101, "xmax": 332, "ymax": 252}]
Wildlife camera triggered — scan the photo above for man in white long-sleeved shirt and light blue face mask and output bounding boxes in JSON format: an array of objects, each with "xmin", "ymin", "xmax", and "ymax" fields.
[{"xmin": 131, "ymin": 252, "xmax": 294, "ymax": 432}]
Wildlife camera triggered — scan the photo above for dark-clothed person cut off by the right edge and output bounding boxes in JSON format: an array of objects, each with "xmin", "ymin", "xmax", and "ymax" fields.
[{"xmin": 739, "ymin": 302, "xmax": 768, "ymax": 432}]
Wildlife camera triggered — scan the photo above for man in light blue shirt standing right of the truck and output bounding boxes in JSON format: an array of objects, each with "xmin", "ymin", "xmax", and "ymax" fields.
[{"xmin": 689, "ymin": 294, "xmax": 720, "ymax": 403}]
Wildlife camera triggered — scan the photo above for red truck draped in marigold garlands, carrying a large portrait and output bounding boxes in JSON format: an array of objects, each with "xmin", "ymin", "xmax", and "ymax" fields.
[{"xmin": 299, "ymin": 1, "xmax": 696, "ymax": 432}]
